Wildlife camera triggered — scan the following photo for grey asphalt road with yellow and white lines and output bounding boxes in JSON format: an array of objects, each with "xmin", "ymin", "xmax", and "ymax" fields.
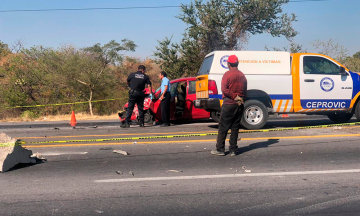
[{"xmin": 0, "ymin": 116, "xmax": 360, "ymax": 215}]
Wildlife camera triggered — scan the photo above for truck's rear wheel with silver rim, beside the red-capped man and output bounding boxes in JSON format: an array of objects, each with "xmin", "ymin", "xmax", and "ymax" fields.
[{"xmin": 241, "ymin": 100, "xmax": 269, "ymax": 130}]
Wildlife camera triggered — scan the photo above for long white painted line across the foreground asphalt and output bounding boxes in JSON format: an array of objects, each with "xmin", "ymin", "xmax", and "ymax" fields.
[{"xmin": 94, "ymin": 169, "xmax": 360, "ymax": 183}]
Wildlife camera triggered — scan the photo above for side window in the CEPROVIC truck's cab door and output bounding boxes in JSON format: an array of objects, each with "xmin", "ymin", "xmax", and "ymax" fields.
[{"xmin": 303, "ymin": 56, "xmax": 340, "ymax": 75}]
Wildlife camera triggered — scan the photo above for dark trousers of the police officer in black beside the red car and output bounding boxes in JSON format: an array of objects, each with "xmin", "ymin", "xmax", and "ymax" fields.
[{"xmin": 125, "ymin": 91, "xmax": 145, "ymax": 124}]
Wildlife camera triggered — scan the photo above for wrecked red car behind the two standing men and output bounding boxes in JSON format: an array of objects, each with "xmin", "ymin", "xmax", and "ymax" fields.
[{"xmin": 119, "ymin": 77, "xmax": 210, "ymax": 124}]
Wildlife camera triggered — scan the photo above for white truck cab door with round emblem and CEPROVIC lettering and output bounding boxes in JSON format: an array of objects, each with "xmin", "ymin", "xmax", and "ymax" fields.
[{"xmin": 299, "ymin": 55, "xmax": 353, "ymax": 112}]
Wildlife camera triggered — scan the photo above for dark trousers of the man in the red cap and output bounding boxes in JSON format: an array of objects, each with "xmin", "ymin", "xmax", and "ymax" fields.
[{"xmin": 216, "ymin": 104, "xmax": 244, "ymax": 152}]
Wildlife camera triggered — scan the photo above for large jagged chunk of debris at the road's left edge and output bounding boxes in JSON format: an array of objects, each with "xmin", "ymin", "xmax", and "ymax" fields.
[{"xmin": 0, "ymin": 133, "xmax": 36, "ymax": 172}]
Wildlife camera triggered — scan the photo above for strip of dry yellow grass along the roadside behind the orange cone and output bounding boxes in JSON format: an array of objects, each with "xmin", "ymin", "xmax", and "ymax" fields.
[{"xmin": 0, "ymin": 113, "xmax": 119, "ymax": 122}]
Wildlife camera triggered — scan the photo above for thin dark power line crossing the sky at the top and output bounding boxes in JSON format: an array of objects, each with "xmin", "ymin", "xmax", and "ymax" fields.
[{"xmin": 0, "ymin": 0, "xmax": 338, "ymax": 13}]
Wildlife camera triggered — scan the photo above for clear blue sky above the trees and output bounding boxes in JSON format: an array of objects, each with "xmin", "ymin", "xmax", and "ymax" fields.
[{"xmin": 0, "ymin": 0, "xmax": 360, "ymax": 58}]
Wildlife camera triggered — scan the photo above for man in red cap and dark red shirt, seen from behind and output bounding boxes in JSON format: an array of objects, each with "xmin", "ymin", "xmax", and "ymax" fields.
[{"xmin": 211, "ymin": 55, "xmax": 247, "ymax": 156}]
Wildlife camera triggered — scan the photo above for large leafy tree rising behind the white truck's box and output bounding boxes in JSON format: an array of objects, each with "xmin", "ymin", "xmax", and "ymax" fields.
[{"xmin": 154, "ymin": 0, "xmax": 298, "ymax": 77}]
